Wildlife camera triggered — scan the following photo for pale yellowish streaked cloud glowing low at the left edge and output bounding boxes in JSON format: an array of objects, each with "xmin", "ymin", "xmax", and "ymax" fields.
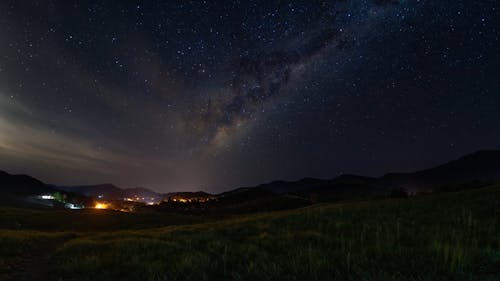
[{"xmin": 0, "ymin": 93, "xmax": 145, "ymax": 174}]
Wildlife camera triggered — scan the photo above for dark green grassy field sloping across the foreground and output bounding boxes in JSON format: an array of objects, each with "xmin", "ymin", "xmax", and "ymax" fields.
[{"xmin": 0, "ymin": 186, "xmax": 500, "ymax": 280}]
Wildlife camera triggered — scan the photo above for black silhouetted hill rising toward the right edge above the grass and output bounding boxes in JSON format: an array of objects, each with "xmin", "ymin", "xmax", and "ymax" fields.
[{"xmin": 255, "ymin": 150, "xmax": 500, "ymax": 199}]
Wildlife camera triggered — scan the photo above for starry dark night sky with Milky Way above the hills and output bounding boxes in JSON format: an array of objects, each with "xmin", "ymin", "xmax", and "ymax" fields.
[{"xmin": 0, "ymin": 0, "xmax": 500, "ymax": 192}]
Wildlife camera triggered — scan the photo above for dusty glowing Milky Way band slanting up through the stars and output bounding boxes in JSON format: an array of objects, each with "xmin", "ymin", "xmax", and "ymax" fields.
[{"xmin": 191, "ymin": 1, "xmax": 397, "ymax": 149}]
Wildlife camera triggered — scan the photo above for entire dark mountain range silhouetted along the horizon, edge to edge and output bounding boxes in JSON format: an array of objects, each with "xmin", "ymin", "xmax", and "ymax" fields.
[{"xmin": 0, "ymin": 150, "xmax": 500, "ymax": 205}]
